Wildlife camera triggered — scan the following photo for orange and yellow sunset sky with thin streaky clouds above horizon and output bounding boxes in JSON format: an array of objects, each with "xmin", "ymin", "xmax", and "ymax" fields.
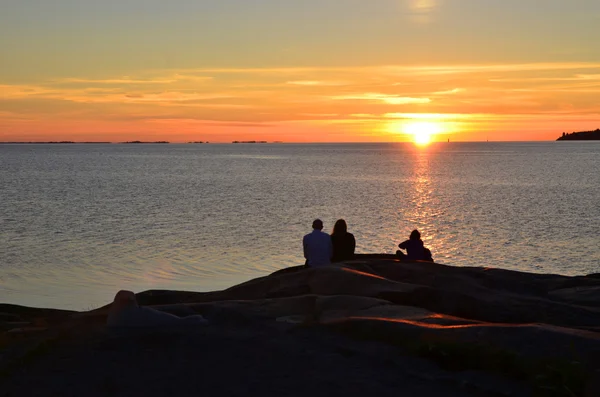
[{"xmin": 0, "ymin": 0, "xmax": 600, "ymax": 142}]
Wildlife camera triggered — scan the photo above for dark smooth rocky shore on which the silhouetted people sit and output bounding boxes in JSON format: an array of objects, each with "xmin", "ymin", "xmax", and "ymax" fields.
[{"xmin": 0, "ymin": 254, "xmax": 600, "ymax": 397}]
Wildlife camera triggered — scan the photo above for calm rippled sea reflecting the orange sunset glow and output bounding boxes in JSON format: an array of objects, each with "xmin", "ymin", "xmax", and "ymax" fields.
[{"xmin": 0, "ymin": 142, "xmax": 600, "ymax": 309}]
